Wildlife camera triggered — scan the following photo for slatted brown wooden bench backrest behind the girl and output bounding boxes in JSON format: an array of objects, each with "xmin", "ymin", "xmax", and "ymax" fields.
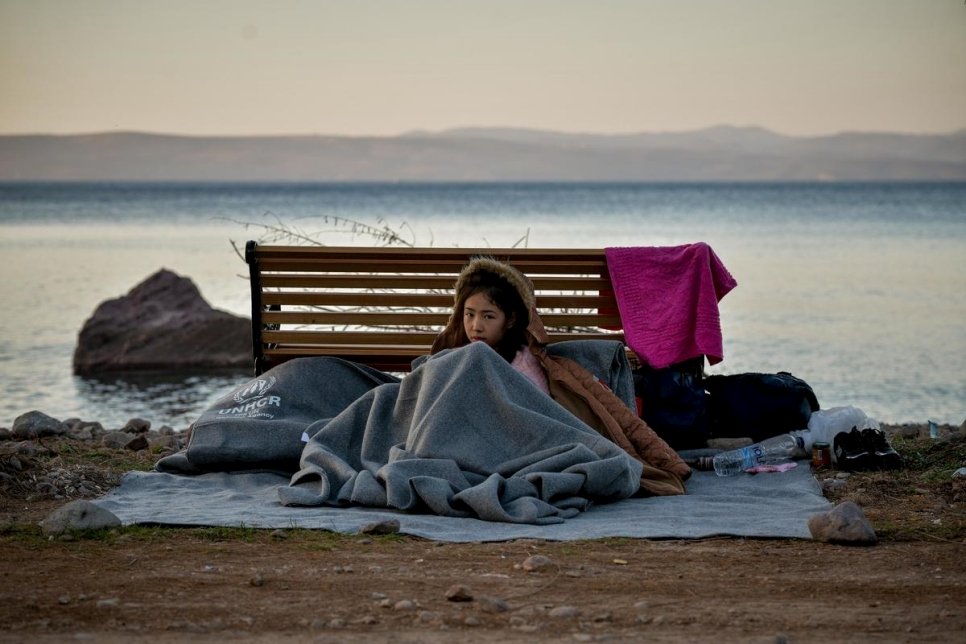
[{"xmin": 245, "ymin": 241, "xmax": 624, "ymax": 374}]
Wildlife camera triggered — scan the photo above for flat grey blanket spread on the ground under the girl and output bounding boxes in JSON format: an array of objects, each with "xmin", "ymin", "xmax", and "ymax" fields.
[{"xmin": 95, "ymin": 462, "xmax": 832, "ymax": 543}]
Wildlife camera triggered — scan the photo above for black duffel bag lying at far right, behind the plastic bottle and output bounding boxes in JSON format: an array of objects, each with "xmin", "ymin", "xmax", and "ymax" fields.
[{"xmin": 704, "ymin": 371, "xmax": 819, "ymax": 442}]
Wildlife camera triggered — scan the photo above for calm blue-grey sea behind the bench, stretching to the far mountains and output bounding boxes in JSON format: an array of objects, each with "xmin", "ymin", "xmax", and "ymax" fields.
[{"xmin": 0, "ymin": 183, "xmax": 966, "ymax": 430}]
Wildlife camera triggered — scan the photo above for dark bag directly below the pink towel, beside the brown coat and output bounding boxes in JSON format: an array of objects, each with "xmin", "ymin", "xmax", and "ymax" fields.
[{"xmin": 634, "ymin": 358, "xmax": 710, "ymax": 450}]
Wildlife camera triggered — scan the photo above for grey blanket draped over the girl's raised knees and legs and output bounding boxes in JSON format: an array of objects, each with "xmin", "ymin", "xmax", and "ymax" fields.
[{"xmin": 279, "ymin": 343, "xmax": 642, "ymax": 524}]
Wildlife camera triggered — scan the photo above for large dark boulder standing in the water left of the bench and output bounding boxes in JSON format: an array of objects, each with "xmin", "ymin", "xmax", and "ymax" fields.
[{"xmin": 74, "ymin": 269, "xmax": 252, "ymax": 375}]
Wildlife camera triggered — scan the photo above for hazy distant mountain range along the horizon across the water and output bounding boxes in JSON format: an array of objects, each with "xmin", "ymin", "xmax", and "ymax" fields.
[{"xmin": 0, "ymin": 126, "xmax": 966, "ymax": 182}]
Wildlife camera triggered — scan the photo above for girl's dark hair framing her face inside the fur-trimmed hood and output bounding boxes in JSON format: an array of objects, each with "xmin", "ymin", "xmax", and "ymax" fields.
[{"xmin": 453, "ymin": 270, "xmax": 530, "ymax": 362}]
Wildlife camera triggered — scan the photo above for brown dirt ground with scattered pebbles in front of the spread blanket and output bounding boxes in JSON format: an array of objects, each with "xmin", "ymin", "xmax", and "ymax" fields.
[{"xmin": 0, "ymin": 428, "xmax": 966, "ymax": 643}]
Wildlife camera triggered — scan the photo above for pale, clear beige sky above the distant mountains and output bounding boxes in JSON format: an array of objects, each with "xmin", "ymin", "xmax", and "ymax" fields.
[{"xmin": 0, "ymin": 0, "xmax": 966, "ymax": 136}]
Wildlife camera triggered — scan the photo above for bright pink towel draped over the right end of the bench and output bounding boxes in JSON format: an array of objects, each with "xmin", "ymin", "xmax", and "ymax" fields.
[{"xmin": 604, "ymin": 242, "xmax": 738, "ymax": 369}]
